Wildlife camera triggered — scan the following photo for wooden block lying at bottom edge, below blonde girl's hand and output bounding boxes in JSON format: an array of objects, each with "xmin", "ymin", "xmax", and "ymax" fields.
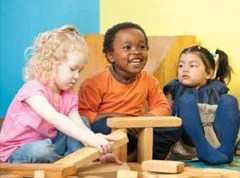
[{"xmin": 77, "ymin": 162, "xmax": 130, "ymax": 178}]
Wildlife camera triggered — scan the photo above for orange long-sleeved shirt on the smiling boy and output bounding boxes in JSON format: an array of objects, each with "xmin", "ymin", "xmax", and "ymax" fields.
[{"xmin": 78, "ymin": 67, "xmax": 171, "ymax": 123}]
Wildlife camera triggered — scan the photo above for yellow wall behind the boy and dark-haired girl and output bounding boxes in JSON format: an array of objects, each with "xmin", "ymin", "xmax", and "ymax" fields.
[{"xmin": 100, "ymin": 0, "xmax": 240, "ymax": 102}]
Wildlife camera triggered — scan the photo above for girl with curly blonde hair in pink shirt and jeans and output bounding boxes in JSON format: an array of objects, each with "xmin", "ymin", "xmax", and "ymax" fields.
[{"xmin": 0, "ymin": 25, "xmax": 120, "ymax": 163}]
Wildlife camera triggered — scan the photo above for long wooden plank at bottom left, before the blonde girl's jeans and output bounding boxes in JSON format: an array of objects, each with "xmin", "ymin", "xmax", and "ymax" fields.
[{"xmin": 0, "ymin": 163, "xmax": 77, "ymax": 178}]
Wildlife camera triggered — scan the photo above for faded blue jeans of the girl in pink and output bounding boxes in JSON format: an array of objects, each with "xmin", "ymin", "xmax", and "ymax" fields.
[{"xmin": 7, "ymin": 117, "xmax": 90, "ymax": 163}]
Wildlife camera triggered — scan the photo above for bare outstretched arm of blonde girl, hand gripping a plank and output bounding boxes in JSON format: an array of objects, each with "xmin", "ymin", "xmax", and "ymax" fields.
[{"xmin": 26, "ymin": 95, "xmax": 111, "ymax": 153}]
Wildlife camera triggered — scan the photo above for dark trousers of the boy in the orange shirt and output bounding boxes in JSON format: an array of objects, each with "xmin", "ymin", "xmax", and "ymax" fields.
[{"xmin": 91, "ymin": 117, "xmax": 182, "ymax": 160}]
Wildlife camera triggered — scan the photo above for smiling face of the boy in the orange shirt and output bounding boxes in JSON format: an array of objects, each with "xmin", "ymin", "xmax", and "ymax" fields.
[{"xmin": 107, "ymin": 28, "xmax": 148, "ymax": 80}]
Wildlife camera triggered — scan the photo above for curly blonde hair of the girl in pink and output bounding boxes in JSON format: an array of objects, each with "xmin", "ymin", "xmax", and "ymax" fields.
[{"xmin": 24, "ymin": 25, "xmax": 88, "ymax": 83}]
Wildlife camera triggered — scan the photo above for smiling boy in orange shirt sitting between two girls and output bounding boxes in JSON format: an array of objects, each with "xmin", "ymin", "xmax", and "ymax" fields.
[{"xmin": 79, "ymin": 22, "xmax": 181, "ymax": 159}]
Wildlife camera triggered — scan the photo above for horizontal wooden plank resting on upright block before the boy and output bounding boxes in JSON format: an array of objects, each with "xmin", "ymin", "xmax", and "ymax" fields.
[{"xmin": 107, "ymin": 116, "xmax": 182, "ymax": 128}]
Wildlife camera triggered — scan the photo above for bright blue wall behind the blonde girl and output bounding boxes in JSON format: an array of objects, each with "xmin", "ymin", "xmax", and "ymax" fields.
[{"xmin": 0, "ymin": 0, "xmax": 100, "ymax": 116}]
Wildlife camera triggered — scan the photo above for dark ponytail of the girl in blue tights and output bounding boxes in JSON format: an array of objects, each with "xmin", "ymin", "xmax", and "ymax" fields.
[{"xmin": 215, "ymin": 49, "xmax": 232, "ymax": 84}]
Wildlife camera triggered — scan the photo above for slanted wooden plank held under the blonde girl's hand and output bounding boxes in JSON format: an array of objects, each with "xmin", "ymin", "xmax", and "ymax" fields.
[{"xmin": 54, "ymin": 131, "xmax": 128, "ymax": 168}]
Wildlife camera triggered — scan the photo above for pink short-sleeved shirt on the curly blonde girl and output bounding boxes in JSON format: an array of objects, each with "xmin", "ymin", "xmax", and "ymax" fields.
[{"xmin": 0, "ymin": 80, "xmax": 78, "ymax": 162}]
